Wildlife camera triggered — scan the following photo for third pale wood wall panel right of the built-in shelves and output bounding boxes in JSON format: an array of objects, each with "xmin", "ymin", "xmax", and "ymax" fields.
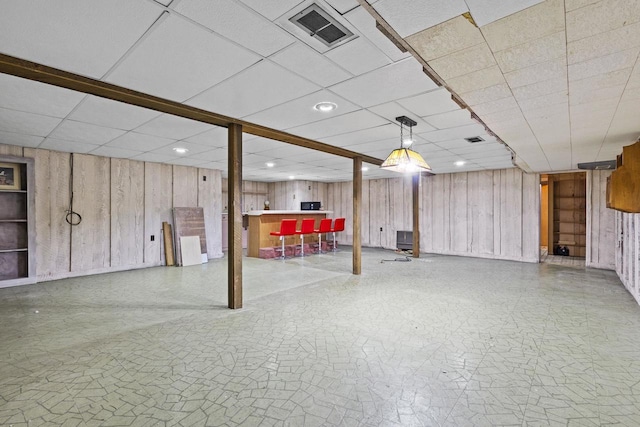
[{"xmin": 110, "ymin": 158, "xmax": 145, "ymax": 267}]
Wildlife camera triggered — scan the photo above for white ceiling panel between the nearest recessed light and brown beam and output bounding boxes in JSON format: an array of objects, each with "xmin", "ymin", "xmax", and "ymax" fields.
[{"xmin": 288, "ymin": 110, "xmax": 388, "ymax": 139}]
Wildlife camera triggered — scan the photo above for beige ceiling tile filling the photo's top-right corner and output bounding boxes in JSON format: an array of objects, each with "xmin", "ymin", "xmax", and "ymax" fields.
[{"xmin": 566, "ymin": 0, "xmax": 640, "ymax": 42}]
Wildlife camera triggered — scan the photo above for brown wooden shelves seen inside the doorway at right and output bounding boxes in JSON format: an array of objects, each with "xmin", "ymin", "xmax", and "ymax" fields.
[{"xmin": 549, "ymin": 173, "xmax": 587, "ymax": 257}]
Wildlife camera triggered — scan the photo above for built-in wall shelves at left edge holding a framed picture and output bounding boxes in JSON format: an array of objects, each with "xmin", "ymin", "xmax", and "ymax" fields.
[{"xmin": 0, "ymin": 156, "xmax": 36, "ymax": 287}]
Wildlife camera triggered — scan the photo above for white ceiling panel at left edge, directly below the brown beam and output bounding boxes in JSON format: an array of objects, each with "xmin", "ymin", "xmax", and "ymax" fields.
[{"xmin": 0, "ymin": 74, "xmax": 85, "ymax": 118}]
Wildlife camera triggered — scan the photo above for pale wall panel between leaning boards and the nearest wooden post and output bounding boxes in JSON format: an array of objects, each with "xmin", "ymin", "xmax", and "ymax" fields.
[{"xmin": 198, "ymin": 169, "xmax": 222, "ymax": 259}]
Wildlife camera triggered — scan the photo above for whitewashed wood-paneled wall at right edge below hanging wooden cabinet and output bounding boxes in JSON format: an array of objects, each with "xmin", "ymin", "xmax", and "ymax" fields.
[{"xmin": 614, "ymin": 211, "xmax": 640, "ymax": 304}]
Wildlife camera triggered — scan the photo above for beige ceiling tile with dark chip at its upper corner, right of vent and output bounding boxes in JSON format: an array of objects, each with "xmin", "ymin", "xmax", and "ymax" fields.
[{"xmin": 406, "ymin": 16, "xmax": 485, "ymax": 61}]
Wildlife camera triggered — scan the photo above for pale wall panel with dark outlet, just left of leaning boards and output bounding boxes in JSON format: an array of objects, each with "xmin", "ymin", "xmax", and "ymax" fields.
[{"xmin": 144, "ymin": 163, "xmax": 173, "ymax": 266}]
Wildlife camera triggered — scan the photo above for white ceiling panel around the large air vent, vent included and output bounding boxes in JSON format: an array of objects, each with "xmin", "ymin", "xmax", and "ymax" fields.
[{"xmin": 279, "ymin": 2, "xmax": 356, "ymax": 53}]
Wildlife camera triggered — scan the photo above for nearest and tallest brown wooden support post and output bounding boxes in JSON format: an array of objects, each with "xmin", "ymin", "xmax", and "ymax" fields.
[{"xmin": 227, "ymin": 123, "xmax": 242, "ymax": 309}]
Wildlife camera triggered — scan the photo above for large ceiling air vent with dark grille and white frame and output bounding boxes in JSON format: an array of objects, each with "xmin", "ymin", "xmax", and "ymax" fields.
[{"xmin": 289, "ymin": 3, "xmax": 353, "ymax": 47}]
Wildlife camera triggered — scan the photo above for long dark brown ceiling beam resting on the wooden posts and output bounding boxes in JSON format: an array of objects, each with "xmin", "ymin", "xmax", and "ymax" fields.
[{"xmin": 0, "ymin": 54, "xmax": 383, "ymax": 166}]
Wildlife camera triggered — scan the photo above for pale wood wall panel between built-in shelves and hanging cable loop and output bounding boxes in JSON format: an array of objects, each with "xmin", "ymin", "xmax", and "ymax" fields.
[{"xmin": 24, "ymin": 148, "xmax": 71, "ymax": 280}]
